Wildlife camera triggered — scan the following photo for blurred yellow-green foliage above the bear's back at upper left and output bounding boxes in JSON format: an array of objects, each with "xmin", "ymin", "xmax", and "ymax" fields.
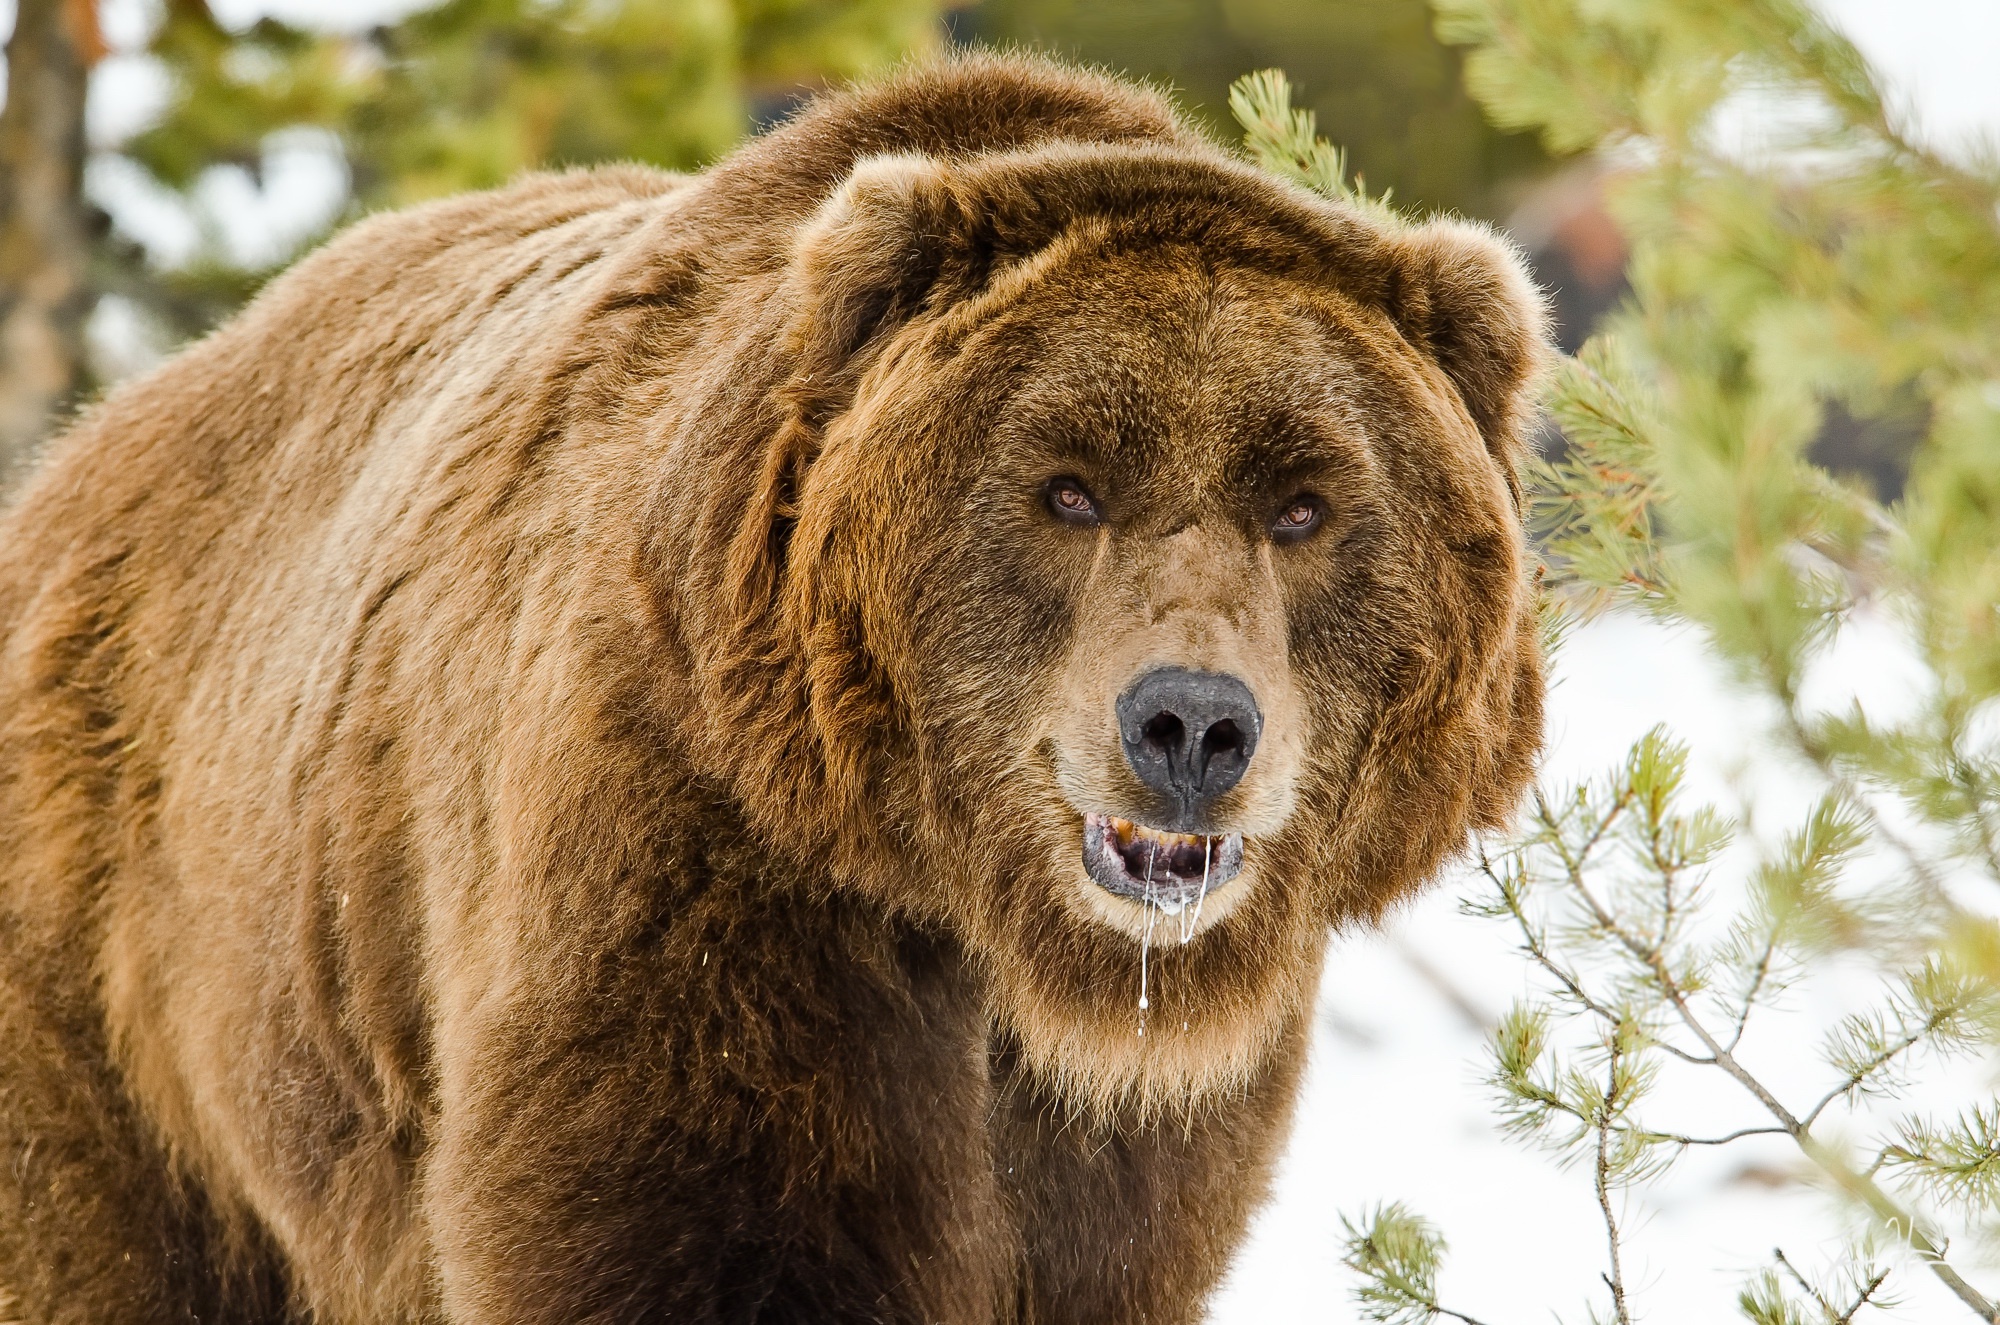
[{"xmin": 88, "ymin": 0, "xmax": 944, "ymax": 338}]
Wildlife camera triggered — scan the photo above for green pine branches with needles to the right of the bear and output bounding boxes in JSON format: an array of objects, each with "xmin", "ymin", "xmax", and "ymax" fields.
[{"xmin": 1236, "ymin": 0, "xmax": 2000, "ymax": 1325}]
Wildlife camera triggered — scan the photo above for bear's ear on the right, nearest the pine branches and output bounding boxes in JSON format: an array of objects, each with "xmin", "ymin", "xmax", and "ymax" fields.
[{"xmin": 1388, "ymin": 220, "xmax": 1552, "ymax": 504}]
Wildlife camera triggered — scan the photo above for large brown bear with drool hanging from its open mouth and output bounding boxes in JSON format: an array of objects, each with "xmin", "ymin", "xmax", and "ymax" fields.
[{"xmin": 0, "ymin": 56, "xmax": 1544, "ymax": 1325}]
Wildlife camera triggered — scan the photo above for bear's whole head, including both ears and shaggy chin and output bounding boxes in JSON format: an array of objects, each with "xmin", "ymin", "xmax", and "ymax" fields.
[{"xmin": 668, "ymin": 144, "xmax": 1546, "ymax": 1105}]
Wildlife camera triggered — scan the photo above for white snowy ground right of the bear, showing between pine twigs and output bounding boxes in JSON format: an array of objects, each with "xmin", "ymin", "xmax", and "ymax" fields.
[{"xmin": 1210, "ymin": 616, "xmax": 2000, "ymax": 1325}]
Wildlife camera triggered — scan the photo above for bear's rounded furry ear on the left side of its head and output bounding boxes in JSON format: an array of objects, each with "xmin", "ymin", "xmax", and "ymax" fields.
[{"xmin": 786, "ymin": 152, "xmax": 962, "ymax": 412}]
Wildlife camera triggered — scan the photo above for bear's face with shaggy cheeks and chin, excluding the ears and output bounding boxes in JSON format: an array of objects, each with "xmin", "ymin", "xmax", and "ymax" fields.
[{"xmin": 704, "ymin": 148, "xmax": 1540, "ymax": 1101}]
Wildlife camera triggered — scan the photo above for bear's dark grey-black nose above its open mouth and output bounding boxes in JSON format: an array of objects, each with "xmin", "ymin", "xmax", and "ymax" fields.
[{"xmin": 1118, "ymin": 667, "xmax": 1264, "ymax": 827}]
